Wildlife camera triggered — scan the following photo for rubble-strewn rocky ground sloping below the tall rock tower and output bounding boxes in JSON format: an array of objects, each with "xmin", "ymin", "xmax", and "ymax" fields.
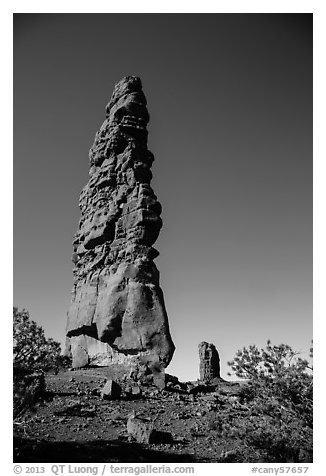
[{"xmin": 14, "ymin": 368, "xmax": 244, "ymax": 463}]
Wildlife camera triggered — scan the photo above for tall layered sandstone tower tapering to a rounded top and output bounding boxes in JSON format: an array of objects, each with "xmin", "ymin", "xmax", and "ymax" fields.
[{"xmin": 67, "ymin": 76, "xmax": 174, "ymax": 371}]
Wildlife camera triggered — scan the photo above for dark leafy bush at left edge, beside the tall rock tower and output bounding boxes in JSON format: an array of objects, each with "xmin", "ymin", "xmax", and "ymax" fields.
[{"xmin": 13, "ymin": 307, "xmax": 63, "ymax": 417}]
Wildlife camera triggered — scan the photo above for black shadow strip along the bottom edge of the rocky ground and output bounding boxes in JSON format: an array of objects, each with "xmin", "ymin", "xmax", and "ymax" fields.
[{"xmin": 13, "ymin": 437, "xmax": 194, "ymax": 463}]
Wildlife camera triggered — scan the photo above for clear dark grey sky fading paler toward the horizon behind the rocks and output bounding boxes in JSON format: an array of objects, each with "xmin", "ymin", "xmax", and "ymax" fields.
[{"xmin": 14, "ymin": 14, "xmax": 312, "ymax": 379}]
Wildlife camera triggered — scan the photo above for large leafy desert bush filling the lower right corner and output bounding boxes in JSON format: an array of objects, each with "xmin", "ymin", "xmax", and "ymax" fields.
[{"xmin": 215, "ymin": 341, "xmax": 313, "ymax": 463}]
